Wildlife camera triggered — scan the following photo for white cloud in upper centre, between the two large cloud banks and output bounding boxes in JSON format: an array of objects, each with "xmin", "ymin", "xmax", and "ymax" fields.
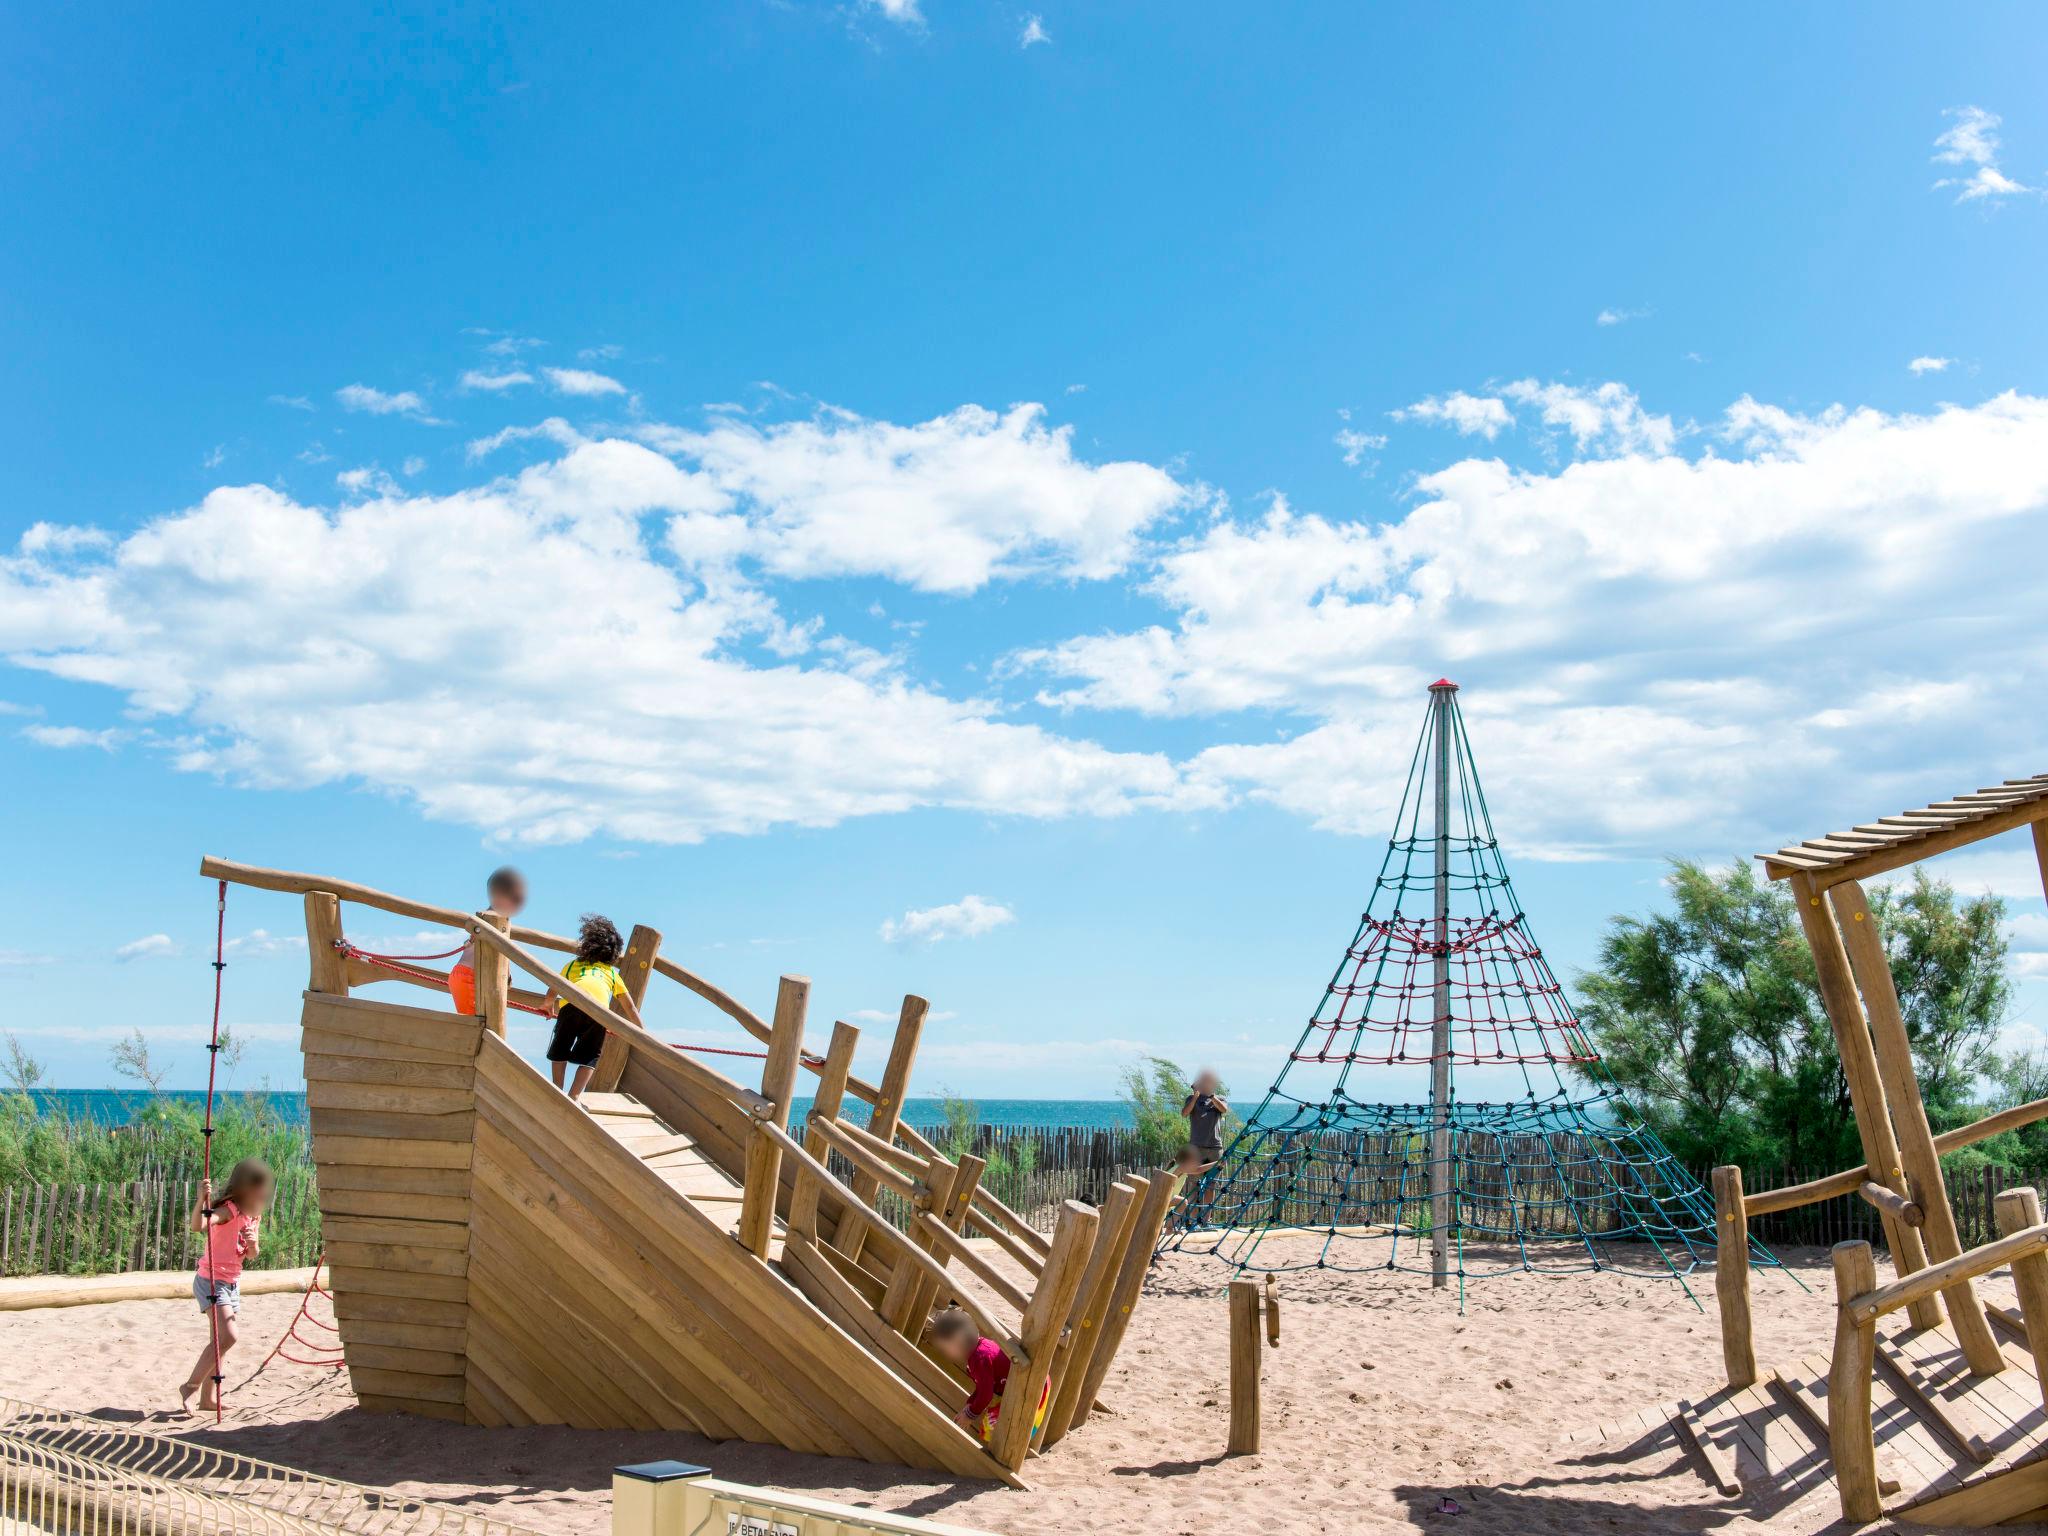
[{"xmin": 643, "ymin": 406, "xmax": 1196, "ymax": 592}]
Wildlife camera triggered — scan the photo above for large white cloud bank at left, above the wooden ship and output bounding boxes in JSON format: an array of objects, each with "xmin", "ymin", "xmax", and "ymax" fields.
[{"xmin": 0, "ymin": 438, "xmax": 1192, "ymax": 842}]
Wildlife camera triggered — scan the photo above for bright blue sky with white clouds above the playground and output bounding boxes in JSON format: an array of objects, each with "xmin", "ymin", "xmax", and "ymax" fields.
[{"xmin": 0, "ymin": 0, "xmax": 2048, "ymax": 1098}]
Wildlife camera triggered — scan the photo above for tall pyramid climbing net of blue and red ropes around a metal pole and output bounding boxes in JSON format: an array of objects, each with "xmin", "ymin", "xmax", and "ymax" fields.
[{"xmin": 1165, "ymin": 682, "xmax": 1776, "ymax": 1294}]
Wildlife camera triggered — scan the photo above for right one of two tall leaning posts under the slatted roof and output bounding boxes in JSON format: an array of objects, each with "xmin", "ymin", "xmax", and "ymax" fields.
[{"xmin": 1827, "ymin": 881, "xmax": 2005, "ymax": 1376}]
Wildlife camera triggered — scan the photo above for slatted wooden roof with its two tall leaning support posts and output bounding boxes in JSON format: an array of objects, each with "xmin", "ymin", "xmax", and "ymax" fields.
[{"xmin": 1757, "ymin": 774, "xmax": 2048, "ymax": 1376}]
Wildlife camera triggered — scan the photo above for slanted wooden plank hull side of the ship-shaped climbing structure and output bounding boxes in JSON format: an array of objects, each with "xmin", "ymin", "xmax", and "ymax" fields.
[{"xmin": 303, "ymin": 993, "xmax": 1016, "ymax": 1483}]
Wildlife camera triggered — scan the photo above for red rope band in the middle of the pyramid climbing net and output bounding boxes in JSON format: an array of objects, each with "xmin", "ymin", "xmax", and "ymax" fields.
[{"xmin": 1294, "ymin": 913, "xmax": 1599, "ymax": 1063}]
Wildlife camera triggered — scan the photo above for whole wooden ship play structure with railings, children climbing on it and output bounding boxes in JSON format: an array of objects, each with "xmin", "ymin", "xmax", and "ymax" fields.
[{"xmin": 201, "ymin": 858, "xmax": 1178, "ymax": 1485}]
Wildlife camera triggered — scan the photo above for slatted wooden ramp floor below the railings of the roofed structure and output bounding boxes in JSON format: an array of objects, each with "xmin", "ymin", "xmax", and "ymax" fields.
[{"xmin": 1571, "ymin": 1307, "xmax": 2048, "ymax": 1530}]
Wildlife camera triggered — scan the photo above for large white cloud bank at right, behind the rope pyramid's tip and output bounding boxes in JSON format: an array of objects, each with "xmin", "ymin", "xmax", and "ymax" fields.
[{"xmin": 1032, "ymin": 387, "xmax": 2048, "ymax": 856}]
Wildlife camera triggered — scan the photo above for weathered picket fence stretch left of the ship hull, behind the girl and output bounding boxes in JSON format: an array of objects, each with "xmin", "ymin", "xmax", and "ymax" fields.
[{"xmin": 0, "ymin": 1165, "xmax": 319, "ymax": 1274}]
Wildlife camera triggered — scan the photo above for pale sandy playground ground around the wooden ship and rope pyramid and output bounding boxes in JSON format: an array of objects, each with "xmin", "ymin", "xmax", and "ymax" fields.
[{"xmin": 0, "ymin": 1239, "xmax": 1982, "ymax": 1536}]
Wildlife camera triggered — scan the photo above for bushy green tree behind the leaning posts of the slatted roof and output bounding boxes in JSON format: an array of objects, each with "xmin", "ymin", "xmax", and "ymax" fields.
[{"xmin": 1579, "ymin": 860, "xmax": 2011, "ymax": 1167}]
